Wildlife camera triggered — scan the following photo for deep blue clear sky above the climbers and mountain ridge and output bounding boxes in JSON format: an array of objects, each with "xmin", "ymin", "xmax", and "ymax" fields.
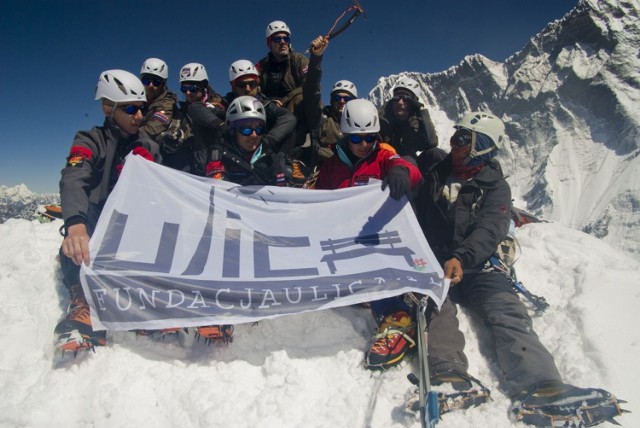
[{"xmin": 0, "ymin": 0, "xmax": 578, "ymax": 192}]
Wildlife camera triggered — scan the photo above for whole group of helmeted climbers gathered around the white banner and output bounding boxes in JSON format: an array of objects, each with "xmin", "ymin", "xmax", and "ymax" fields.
[{"xmin": 55, "ymin": 17, "xmax": 624, "ymax": 423}]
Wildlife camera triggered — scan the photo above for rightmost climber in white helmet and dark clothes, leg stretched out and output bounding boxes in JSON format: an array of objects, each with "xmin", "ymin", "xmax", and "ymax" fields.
[{"xmin": 414, "ymin": 112, "xmax": 620, "ymax": 426}]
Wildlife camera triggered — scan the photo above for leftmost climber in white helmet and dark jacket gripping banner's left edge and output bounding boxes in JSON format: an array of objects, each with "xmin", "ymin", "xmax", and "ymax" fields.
[{"xmin": 54, "ymin": 70, "xmax": 160, "ymax": 353}]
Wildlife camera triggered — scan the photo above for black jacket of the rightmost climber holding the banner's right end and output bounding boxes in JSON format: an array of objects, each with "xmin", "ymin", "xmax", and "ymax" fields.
[{"xmin": 415, "ymin": 156, "xmax": 511, "ymax": 269}]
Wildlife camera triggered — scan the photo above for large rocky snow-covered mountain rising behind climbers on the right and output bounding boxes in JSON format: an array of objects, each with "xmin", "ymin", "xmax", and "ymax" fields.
[{"xmin": 370, "ymin": 0, "xmax": 640, "ymax": 255}]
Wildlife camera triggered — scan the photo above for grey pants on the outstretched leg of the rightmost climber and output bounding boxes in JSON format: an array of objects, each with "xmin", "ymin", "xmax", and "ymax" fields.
[{"xmin": 450, "ymin": 272, "xmax": 561, "ymax": 397}]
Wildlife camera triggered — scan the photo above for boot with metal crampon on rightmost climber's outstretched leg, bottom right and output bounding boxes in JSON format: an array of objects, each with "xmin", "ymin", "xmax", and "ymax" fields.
[{"xmin": 512, "ymin": 387, "xmax": 630, "ymax": 428}]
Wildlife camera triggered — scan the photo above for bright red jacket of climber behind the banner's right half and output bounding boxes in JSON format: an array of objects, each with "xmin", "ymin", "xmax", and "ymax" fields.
[{"xmin": 315, "ymin": 144, "xmax": 422, "ymax": 189}]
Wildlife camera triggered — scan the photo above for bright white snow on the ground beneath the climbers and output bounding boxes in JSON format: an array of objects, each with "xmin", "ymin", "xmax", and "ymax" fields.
[{"xmin": 0, "ymin": 219, "xmax": 640, "ymax": 428}]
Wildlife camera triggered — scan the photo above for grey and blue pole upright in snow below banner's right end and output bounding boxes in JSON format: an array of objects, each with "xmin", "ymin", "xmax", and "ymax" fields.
[{"xmin": 409, "ymin": 293, "xmax": 440, "ymax": 428}]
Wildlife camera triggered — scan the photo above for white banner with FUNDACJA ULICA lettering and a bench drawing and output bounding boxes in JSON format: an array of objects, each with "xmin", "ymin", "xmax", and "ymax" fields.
[{"xmin": 81, "ymin": 155, "xmax": 449, "ymax": 330}]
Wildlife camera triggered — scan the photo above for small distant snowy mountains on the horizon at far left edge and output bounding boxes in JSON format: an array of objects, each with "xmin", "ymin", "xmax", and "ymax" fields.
[{"xmin": 0, "ymin": 184, "xmax": 60, "ymax": 223}]
